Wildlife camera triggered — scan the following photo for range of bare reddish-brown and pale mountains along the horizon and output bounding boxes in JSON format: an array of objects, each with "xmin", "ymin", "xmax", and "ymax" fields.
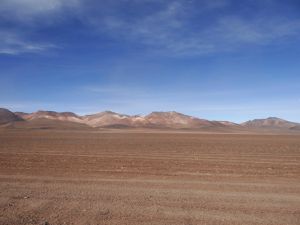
[{"xmin": 0, "ymin": 108, "xmax": 300, "ymax": 132}]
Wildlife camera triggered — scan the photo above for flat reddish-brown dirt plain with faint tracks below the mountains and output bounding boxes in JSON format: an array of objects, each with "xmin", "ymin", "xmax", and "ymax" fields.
[{"xmin": 0, "ymin": 130, "xmax": 300, "ymax": 225}]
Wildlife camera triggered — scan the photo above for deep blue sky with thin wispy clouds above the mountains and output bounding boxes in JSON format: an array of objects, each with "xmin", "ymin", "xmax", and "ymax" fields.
[{"xmin": 0, "ymin": 0, "xmax": 300, "ymax": 122}]
